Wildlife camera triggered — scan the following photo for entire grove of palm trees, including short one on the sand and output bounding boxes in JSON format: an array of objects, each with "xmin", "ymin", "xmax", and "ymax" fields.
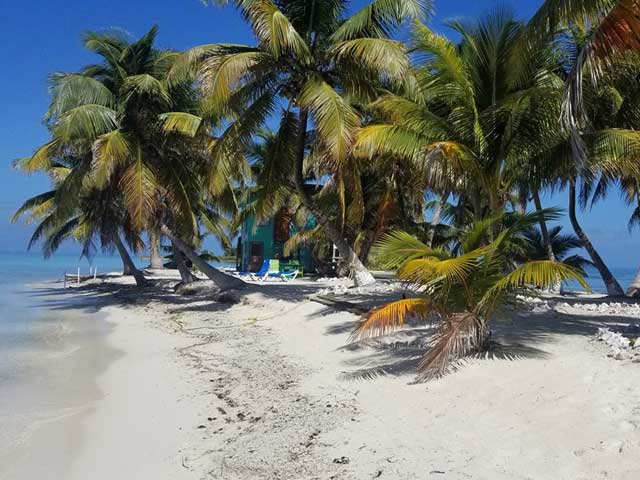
[{"xmin": 13, "ymin": 0, "xmax": 640, "ymax": 379}]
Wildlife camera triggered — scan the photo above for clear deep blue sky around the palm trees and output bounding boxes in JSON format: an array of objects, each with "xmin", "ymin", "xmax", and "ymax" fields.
[{"xmin": 0, "ymin": 0, "xmax": 640, "ymax": 267}]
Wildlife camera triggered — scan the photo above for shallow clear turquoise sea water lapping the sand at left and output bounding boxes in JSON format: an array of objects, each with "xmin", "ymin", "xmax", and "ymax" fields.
[{"xmin": 0, "ymin": 254, "xmax": 131, "ymax": 480}]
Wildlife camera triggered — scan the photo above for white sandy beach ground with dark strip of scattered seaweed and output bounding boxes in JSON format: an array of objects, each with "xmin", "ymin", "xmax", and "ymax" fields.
[{"xmin": 26, "ymin": 274, "xmax": 640, "ymax": 480}]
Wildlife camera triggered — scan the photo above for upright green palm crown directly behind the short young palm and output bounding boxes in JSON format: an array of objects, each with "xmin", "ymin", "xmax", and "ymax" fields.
[{"xmin": 355, "ymin": 10, "xmax": 562, "ymax": 230}]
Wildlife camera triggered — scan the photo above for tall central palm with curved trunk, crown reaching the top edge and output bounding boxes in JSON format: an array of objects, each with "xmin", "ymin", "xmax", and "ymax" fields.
[{"xmin": 175, "ymin": 0, "xmax": 429, "ymax": 285}]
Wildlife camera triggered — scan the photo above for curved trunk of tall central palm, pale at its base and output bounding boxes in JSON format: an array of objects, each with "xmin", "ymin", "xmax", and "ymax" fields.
[{"xmin": 294, "ymin": 109, "xmax": 376, "ymax": 286}]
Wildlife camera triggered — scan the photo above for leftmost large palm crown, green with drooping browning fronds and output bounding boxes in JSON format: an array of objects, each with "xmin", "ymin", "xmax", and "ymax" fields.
[{"xmin": 16, "ymin": 27, "xmax": 244, "ymax": 288}]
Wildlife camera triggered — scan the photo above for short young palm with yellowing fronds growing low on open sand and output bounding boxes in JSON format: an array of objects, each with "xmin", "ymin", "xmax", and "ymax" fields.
[{"xmin": 353, "ymin": 213, "xmax": 589, "ymax": 381}]
